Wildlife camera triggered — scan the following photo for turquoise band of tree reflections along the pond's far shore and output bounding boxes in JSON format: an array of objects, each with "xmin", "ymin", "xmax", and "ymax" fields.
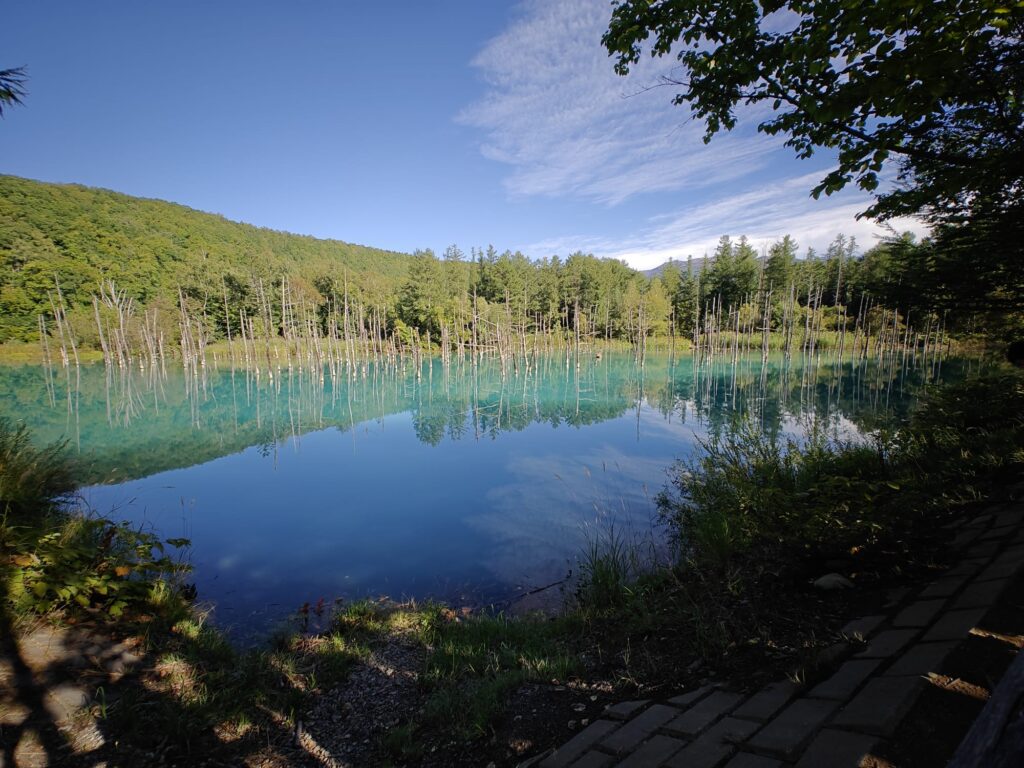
[{"xmin": 9, "ymin": 354, "xmax": 974, "ymax": 482}]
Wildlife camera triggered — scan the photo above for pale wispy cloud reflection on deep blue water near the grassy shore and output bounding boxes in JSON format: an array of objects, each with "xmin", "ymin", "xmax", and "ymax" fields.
[{"xmin": 466, "ymin": 445, "xmax": 666, "ymax": 585}]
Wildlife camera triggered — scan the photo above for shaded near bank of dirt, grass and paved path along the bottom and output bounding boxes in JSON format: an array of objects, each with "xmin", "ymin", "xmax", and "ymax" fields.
[{"xmin": 0, "ymin": 484, "xmax": 1024, "ymax": 767}]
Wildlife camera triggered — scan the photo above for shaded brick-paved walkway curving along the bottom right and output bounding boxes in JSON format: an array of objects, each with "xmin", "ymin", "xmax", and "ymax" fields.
[{"xmin": 522, "ymin": 502, "xmax": 1024, "ymax": 768}]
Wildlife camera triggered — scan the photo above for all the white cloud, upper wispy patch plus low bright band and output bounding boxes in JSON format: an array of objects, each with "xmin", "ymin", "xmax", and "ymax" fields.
[{"xmin": 468, "ymin": 0, "xmax": 925, "ymax": 268}]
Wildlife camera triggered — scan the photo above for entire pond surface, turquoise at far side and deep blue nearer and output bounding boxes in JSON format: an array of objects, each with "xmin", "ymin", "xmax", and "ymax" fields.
[{"xmin": 0, "ymin": 354, "xmax": 953, "ymax": 634}]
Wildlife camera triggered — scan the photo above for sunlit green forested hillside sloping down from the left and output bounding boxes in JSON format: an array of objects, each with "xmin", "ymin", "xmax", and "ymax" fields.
[{"xmin": 0, "ymin": 176, "xmax": 410, "ymax": 341}]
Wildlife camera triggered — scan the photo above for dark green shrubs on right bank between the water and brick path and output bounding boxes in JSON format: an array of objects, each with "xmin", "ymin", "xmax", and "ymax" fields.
[{"xmin": 657, "ymin": 371, "xmax": 1024, "ymax": 566}]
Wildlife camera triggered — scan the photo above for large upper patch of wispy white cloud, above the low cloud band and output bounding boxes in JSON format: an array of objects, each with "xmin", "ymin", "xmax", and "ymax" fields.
[{"xmin": 459, "ymin": 0, "xmax": 779, "ymax": 205}]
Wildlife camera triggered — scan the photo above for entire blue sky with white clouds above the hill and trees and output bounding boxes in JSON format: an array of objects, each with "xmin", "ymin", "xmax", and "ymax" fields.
[{"xmin": 0, "ymin": 0, "xmax": 924, "ymax": 268}]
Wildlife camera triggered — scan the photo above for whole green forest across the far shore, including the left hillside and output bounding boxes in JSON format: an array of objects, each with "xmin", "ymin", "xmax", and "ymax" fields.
[{"xmin": 0, "ymin": 176, "xmax": 1022, "ymax": 360}]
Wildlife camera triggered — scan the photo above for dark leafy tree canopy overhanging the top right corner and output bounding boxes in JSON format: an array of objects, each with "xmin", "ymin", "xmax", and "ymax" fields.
[{"xmin": 603, "ymin": 0, "xmax": 1024, "ymax": 225}]
